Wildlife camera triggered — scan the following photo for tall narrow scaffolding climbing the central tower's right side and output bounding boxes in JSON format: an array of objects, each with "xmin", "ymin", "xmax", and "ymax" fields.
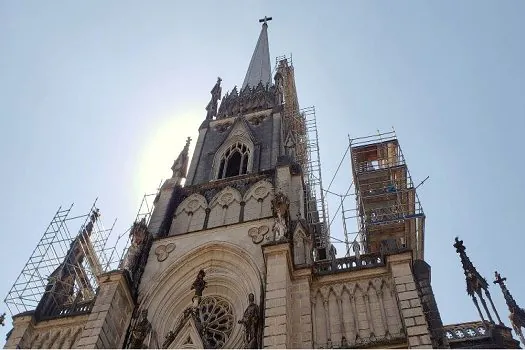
[{"xmin": 275, "ymin": 55, "xmax": 330, "ymax": 259}]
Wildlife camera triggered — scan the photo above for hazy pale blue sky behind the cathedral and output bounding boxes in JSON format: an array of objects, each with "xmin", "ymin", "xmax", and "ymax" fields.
[{"xmin": 0, "ymin": 0, "xmax": 525, "ymax": 339}]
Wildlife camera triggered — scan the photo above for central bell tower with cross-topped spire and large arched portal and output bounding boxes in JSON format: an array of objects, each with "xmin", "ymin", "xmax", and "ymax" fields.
[{"xmin": 125, "ymin": 17, "xmax": 327, "ymax": 348}]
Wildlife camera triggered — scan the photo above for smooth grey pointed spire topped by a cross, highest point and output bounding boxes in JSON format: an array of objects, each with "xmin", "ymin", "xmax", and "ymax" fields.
[{"xmin": 241, "ymin": 17, "xmax": 272, "ymax": 91}]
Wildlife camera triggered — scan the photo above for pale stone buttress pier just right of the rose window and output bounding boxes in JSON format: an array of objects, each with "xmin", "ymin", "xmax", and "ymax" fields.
[{"xmin": 263, "ymin": 243, "xmax": 293, "ymax": 349}]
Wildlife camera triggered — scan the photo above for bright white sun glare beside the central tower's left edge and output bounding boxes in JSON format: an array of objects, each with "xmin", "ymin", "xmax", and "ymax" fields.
[{"xmin": 134, "ymin": 110, "xmax": 202, "ymax": 202}]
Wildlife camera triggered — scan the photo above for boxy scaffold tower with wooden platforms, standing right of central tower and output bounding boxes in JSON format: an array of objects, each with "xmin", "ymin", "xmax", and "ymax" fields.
[{"xmin": 345, "ymin": 130, "xmax": 425, "ymax": 259}]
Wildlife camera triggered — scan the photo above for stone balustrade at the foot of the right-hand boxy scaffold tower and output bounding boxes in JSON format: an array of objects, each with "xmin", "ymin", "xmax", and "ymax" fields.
[{"xmin": 314, "ymin": 254, "xmax": 385, "ymax": 275}]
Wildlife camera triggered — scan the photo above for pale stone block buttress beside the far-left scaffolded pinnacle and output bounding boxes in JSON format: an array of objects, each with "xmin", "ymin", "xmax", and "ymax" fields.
[{"xmin": 77, "ymin": 271, "xmax": 134, "ymax": 349}]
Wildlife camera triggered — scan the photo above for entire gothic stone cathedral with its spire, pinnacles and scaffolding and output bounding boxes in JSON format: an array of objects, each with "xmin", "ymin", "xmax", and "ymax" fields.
[{"xmin": 2, "ymin": 17, "xmax": 525, "ymax": 349}]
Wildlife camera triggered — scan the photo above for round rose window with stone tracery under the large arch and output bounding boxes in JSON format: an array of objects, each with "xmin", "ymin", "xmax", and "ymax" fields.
[{"xmin": 199, "ymin": 296, "xmax": 234, "ymax": 349}]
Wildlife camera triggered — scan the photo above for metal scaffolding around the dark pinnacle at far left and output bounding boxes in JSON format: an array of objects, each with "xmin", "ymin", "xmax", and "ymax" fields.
[{"xmin": 4, "ymin": 195, "xmax": 155, "ymax": 319}]
